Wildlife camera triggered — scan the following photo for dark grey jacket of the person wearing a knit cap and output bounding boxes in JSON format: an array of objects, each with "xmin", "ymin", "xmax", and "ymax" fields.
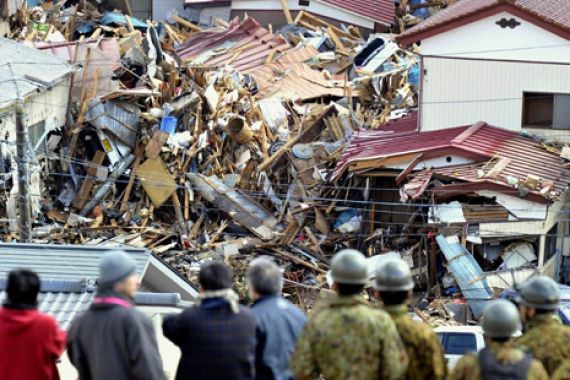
[{"xmin": 67, "ymin": 294, "xmax": 165, "ymax": 380}]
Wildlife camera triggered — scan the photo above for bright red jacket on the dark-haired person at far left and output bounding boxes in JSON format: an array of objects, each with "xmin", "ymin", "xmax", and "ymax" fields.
[{"xmin": 0, "ymin": 307, "xmax": 66, "ymax": 380}]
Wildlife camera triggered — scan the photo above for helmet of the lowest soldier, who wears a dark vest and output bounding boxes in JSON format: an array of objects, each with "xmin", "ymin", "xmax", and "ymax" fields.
[{"xmin": 481, "ymin": 300, "xmax": 522, "ymax": 338}]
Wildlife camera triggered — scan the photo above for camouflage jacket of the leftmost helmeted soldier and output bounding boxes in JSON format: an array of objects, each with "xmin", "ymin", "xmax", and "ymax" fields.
[{"xmin": 291, "ymin": 296, "xmax": 408, "ymax": 380}]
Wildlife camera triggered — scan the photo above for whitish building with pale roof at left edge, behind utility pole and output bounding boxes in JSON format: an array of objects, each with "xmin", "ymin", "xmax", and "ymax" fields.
[{"xmin": 0, "ymin": 38, "xmax": 74, "ymax": 226}]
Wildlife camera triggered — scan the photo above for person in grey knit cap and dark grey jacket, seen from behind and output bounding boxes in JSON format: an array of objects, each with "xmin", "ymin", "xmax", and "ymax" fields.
[{"xmin": 67, "ymin": 251, "xmax": 165, "ymax": 380}]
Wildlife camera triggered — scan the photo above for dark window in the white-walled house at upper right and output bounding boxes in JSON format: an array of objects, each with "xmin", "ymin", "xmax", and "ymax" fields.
[{"xmin": 523, "ymin": 92, "xmax": 570, "ymax": 129}]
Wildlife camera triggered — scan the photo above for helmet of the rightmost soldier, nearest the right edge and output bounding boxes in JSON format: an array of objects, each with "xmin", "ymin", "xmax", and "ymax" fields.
[{"xmin": 519, "ymin": 276, "xmax": 560, "ymax": 311}]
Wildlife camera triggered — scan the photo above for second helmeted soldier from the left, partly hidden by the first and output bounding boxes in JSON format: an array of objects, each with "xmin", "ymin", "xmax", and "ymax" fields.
[{"xmin": 376, "ymin": 259, "xmax": 447, "ymax": 380}]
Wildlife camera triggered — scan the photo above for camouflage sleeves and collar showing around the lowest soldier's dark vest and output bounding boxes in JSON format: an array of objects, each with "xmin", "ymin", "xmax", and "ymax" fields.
[{"xmin": 448, "ymin": 342, "xmax": 548, "ymax": 380}]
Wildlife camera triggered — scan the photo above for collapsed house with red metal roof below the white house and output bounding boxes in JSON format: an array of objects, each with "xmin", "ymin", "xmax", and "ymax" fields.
[{"xmin": 335, "ymin": 114, "xmax": 570, "ymax": 314}]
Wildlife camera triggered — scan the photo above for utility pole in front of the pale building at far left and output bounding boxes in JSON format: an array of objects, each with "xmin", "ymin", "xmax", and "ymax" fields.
[{"xmin": 8, "ymin": 64, "xmax": 32, "ymax": 242}]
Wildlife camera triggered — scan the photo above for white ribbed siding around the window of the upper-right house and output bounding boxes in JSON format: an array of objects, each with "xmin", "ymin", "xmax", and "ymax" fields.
[{"xmin": 420, "ymin": 57, "xmax": 570, "ymax": 141}]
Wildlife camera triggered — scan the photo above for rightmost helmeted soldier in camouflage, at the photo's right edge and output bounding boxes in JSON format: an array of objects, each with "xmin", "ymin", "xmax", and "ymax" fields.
[{"xmin": 517, "ymin": 276, "xmax": 570, "ymax": 375}]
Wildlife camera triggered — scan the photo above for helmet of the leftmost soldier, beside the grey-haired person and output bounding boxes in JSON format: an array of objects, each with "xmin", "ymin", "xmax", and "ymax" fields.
[{"xmin": 331, "ymin": 249, "xmax": 368, "ymax": 285}]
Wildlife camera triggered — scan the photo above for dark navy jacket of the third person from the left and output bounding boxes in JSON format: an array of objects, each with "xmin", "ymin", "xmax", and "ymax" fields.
[{"xmin": 162, "ymin": 298, "xmax": 255, "ymax": 380}]
